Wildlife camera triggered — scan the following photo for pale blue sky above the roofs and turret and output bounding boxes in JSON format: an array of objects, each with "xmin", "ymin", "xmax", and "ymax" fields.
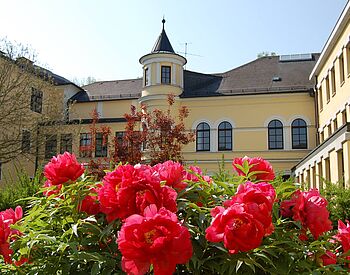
[{"xmin": 0, "ymin": 0, "xmax": 347, "ymax": 80}]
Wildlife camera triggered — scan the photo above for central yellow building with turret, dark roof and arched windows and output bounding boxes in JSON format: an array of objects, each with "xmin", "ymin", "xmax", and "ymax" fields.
[{"xmin": 64, "ymin": 21, "xmax": 318, "ymax": 178}]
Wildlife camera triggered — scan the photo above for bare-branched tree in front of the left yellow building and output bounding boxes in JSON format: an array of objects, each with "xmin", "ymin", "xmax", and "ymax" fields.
[{"xmin": 0, "ymin": 39, "xmax": 63, "ymax": 166}]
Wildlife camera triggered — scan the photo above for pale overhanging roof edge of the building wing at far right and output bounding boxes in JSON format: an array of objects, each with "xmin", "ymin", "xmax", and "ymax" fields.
[{"xmin": 309, "ymin": 1, "xmax": 350, "ymax": 79}]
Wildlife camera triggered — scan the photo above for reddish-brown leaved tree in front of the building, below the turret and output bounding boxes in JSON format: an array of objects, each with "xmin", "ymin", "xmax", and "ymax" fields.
[{"xmin": 80, "ymin": 95, "xmax": 194, "ymax": 171}]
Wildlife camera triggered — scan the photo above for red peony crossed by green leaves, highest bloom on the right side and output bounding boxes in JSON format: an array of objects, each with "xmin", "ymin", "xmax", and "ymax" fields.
[{"xmin": 232, "ymin": 157, "xmax": 275, "ymax": 181}]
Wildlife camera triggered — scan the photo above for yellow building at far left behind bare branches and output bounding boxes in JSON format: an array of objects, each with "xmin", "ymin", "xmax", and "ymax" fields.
[{"xmin": 0, "ymin": 51, "xmax": 82, "ymax": 183}]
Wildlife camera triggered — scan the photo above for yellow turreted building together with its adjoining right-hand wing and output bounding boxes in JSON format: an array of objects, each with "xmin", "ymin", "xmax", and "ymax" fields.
[{"xmin": 2, "ymin": 4, "xmax": 350, "ymax": 183}]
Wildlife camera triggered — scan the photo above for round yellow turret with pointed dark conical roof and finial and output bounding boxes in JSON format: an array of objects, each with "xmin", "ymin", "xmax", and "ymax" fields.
[{"xmin": 139, "ymin": 18, "xmax": 187, "ymax": 108}]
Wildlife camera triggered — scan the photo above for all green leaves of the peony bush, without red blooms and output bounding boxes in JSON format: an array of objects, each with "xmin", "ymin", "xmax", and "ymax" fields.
[{"xmin": 0, "ymin": 165, "xmax": 348, "ymax": 275}]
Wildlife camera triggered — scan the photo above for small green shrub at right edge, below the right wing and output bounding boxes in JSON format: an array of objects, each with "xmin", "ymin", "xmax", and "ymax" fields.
[{"xmin": 321, "ymin": 182, "xmax": 350, "ymax": 226}]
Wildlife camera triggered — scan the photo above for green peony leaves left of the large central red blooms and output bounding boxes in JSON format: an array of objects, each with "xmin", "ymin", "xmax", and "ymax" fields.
[{"xmin": 6, "ymin": 179, "xmax": 121, "ymax": 274}]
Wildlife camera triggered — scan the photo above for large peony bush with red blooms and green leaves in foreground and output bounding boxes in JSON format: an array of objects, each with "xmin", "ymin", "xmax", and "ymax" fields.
[{"xmin": 0, "ymin": 153, "xmax": 350, "ymax": 275}]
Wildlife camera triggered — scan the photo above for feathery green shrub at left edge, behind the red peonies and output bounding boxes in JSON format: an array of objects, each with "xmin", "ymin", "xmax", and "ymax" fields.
[{"xmin": 0, "ymin": 168, "xmax": 43, "ymax": 211}]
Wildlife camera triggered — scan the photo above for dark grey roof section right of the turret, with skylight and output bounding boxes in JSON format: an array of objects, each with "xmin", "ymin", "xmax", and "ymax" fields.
[{"xmin": 181, "ymin": 54, "xmax": 319, "ymax": 97}]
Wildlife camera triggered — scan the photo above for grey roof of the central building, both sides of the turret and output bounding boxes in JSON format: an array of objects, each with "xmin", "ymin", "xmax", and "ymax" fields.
[{"xmin": 71, "ymin": 53, "xmax": 319, "ymax": 102}]
